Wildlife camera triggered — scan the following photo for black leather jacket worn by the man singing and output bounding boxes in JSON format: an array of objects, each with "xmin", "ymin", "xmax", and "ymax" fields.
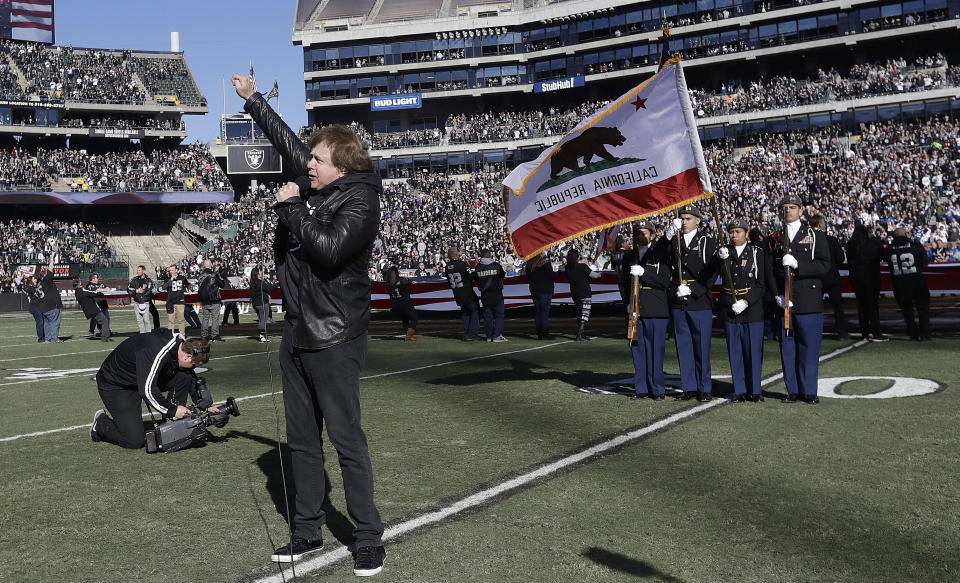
[{"xmin": 244, "ymin": 93, "xmax": 382, "ymax": 350}]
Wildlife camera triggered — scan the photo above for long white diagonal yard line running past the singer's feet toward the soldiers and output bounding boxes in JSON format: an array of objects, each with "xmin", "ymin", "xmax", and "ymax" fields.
[{"xmin": 257, "ymin": 340, "xmax": 867, "ymax": 583}]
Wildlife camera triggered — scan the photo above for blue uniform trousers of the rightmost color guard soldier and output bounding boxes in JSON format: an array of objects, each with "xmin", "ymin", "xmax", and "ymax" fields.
[{"xmin": 777, "ymin": 312, "xmax": 823, "ymax": 397}]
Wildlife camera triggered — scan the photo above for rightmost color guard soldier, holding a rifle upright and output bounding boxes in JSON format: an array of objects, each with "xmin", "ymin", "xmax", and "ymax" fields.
[{"xmin": 768, "ymin": 194, "xmax": 830, "ymax": 404}]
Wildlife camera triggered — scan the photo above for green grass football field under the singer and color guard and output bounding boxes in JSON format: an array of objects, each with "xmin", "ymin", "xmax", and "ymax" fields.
[{"xmin": 0, "ymin": 310, "xmax": 960, "ymax": 582}]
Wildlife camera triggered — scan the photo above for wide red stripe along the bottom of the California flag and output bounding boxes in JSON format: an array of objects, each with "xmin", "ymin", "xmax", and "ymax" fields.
[{"xmin": 513, "ymin": 168, "xmax": 703, "ymax": 256}]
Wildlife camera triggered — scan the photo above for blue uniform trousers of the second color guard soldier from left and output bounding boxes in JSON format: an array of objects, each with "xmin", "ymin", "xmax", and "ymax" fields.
[{"xmin": 670, "ymin": 308, "xmax": 713, "ymax": 394}]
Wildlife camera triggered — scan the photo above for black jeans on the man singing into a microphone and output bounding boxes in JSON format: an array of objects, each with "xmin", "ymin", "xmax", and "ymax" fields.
[{"xmin": 280, "ymin": 322, "xmax": 383, "ymax": 547}]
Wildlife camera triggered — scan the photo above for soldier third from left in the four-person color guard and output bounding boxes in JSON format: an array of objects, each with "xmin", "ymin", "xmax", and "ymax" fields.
[{"xmin": 717, "ymin": 219, "xmax": 767, "ymax": 403}]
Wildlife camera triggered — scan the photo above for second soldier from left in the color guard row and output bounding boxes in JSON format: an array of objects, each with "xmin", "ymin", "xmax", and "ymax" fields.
[{"xmin": 666, "ymin": 205, "xmax": 717, "ymax": 402}]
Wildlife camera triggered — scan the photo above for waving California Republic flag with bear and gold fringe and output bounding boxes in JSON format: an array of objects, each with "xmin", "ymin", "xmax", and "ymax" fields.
[{"xmin": 503, "ymin": 59, "xmax": 713, "ymax": 258}]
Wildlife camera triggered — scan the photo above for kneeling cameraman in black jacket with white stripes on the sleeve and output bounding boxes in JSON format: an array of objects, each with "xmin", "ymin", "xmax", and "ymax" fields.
[{"xmin": 90, "ymin": 328, "xmax": 219, "ymax": 449}]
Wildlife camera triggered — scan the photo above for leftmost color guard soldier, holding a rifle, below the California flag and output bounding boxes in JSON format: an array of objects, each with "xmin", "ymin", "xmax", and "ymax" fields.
[{"xmin": 623, "ymin": 222, "xmax": 671, "ymax": 401}]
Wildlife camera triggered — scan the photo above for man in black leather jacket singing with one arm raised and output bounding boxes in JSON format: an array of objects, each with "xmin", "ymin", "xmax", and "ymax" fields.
[{"xmin": 233, "ymin": 75, "xmax": 386, "ymax": 577}]
